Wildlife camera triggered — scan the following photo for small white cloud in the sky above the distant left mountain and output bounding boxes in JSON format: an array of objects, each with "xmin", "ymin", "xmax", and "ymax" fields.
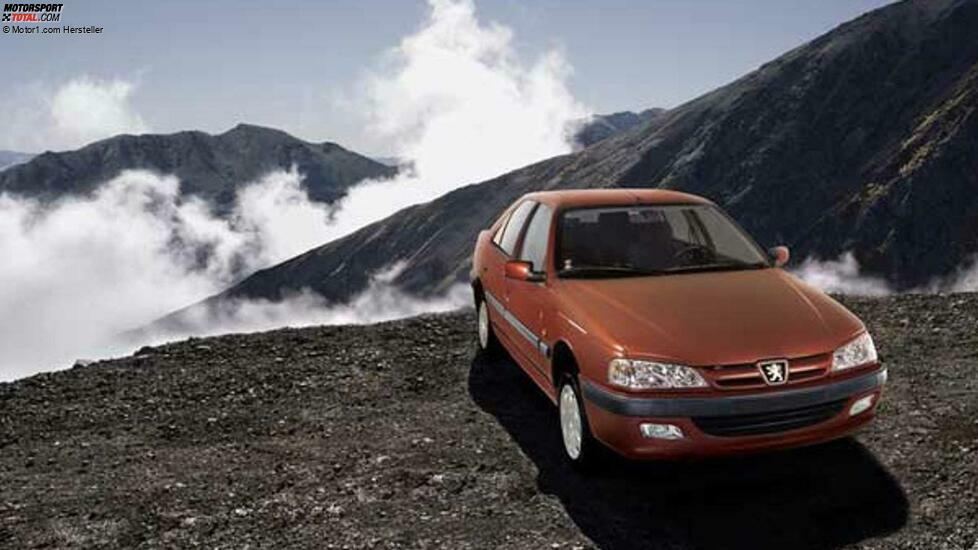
[{"xmin": 0, "ymin": 76, "xmax": 149, "ymax": 152}]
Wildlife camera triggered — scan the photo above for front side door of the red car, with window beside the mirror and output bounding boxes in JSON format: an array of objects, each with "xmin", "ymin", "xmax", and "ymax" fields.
[{"xmin": 505, "ymin": 203, "xmax": 553, "ymax": 380}]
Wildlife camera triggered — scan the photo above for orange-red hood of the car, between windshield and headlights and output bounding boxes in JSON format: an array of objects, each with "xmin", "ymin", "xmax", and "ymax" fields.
[{"xmin": 561, "ymin": 268, "xmax": 863, "ymax": 365}]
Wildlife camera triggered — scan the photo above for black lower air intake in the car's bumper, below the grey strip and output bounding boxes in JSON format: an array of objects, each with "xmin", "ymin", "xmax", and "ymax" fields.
[{"xmin": 693, "ymin": 399, "xmax": 846, "ymax": 437}]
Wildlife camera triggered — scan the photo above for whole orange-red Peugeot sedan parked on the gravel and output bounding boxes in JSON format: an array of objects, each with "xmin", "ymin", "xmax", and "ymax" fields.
[{"xmin": 471, "ymin": 190, "xmax": 886, "ymax": 465}]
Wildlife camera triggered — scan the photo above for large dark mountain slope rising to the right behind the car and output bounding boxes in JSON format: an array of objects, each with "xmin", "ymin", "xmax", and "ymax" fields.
[{"xmin": 191, "ymin": 0, "xmax": 978, "ymax": 312}]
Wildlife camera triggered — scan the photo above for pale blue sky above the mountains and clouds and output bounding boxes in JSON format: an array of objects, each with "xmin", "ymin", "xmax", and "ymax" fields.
[{"xmin": 0, "ymin": 0, "xmax": 888, "ymax": 154}]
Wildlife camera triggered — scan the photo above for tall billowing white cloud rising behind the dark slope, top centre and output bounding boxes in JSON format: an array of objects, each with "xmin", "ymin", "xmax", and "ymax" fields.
[{"xmin": 322, "ymin": 0, "xmax": 589, "ymax": 242}]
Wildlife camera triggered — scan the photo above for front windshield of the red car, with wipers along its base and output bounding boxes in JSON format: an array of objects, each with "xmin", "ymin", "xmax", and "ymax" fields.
[{"xmin": 555, "ymin": 204, "xmax": 770, "ymax": 277}]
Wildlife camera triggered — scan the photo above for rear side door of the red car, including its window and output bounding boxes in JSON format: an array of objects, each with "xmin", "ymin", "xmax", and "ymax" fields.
[{"xmin": 482, "ymin": 200, "xmax": 537, "ymax": 351}]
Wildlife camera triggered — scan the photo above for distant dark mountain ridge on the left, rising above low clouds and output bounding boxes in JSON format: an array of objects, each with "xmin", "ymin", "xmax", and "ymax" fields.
[{"xmin": 0, "ymin": 124, "xmax": 396, "ymax": 212}]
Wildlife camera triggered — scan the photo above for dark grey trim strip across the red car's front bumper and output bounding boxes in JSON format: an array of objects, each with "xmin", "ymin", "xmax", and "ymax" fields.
[{"xmin": 581, "ymin": 368, "xmax": 887, "ymax": 417}]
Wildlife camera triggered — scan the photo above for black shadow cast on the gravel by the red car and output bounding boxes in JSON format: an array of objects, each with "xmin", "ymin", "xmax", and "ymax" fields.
[{"xmin": 469, "ymin": 356, "xmax": 907, "ymax": 549}]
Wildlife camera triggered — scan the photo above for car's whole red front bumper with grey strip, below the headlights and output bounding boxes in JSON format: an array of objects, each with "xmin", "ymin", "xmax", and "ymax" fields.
[{"xmin": 581, "ymin": 368, "xmax": 887, "ymax": 459}]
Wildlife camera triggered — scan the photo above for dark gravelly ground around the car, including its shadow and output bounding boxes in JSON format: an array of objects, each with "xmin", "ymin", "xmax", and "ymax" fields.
[{"xmin": 0, "ymin": 295, "xmax": 978, "ymax": 550}]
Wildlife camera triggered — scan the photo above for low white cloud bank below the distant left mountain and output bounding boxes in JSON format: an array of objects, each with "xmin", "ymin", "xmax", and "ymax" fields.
[{"xmin": 0, "ymin": 171, "xmax": 340, "ymax": 378}]
